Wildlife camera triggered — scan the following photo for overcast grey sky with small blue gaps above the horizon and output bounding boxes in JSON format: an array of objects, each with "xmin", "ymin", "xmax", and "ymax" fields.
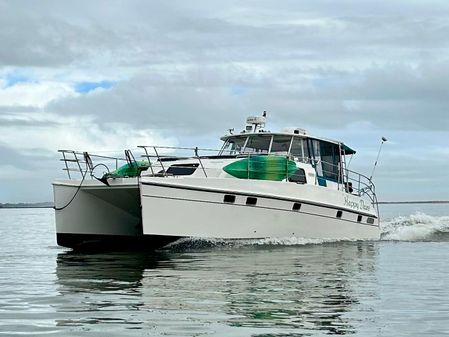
[{"xmin": 0, "ymin": 0, "xmax": 449, "ymax": 202}]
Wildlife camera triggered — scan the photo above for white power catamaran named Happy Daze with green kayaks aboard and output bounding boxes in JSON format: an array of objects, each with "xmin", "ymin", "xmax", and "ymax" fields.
[{"xmin": 53, "ymin": 116, "xmax": 380, "ymax": 250}]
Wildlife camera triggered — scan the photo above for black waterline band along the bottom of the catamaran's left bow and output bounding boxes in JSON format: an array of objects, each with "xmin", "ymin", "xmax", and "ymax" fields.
[{"xmin": 56, "ymin": 233, "xmax": 181, "ymax": 252}]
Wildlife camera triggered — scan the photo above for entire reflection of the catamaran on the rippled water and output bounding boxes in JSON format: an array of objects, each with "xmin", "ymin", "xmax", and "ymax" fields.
[{"xmin": 56, "ymin": 242, "xmax": 378, "ymax": 336}]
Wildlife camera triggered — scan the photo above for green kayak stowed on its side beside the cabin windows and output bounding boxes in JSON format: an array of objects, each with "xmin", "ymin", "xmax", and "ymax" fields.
[{"xmin": 223, "ymin": 155, "xmax": 297, "ymax": 181}]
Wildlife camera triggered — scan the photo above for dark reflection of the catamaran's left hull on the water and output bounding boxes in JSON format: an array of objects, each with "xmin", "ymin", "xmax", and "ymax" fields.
[{"xmin": 56, "ymin": 252, "xmax": 167, "ymax": 329}]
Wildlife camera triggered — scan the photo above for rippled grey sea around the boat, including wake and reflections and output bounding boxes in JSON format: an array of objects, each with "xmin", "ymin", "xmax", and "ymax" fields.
[{"xmin": 0, "ymin": 206, "xmax": 449, "ymax": 337}]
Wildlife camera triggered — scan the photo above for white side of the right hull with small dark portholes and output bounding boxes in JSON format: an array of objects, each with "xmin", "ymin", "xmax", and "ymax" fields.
[{"xmin": 140, "ymin": 177, "xmax": 380, "ymax": 240}]
